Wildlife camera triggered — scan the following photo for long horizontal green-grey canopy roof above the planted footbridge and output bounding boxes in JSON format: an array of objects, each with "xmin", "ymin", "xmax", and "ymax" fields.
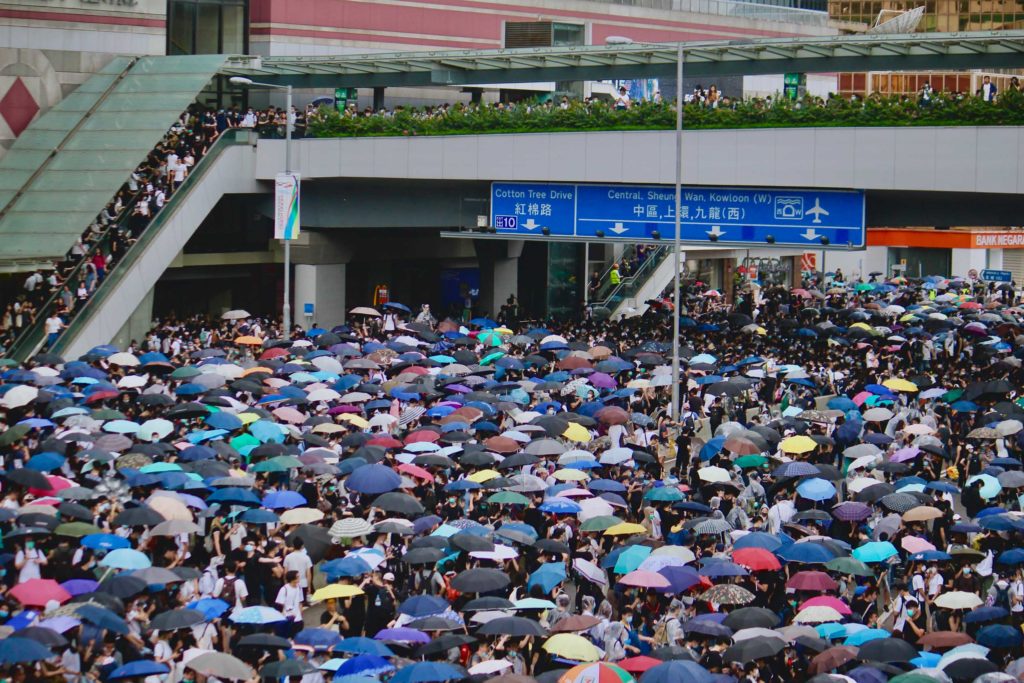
[{"xmin": 220, "ymin": 31, "xmax": 1024, "ymax": 88}]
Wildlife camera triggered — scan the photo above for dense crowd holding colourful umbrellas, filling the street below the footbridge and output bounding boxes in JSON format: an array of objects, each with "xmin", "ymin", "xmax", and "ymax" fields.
[{"xmin": 0, "ymin": 278, "xmax": 1024, "ymax": 683}]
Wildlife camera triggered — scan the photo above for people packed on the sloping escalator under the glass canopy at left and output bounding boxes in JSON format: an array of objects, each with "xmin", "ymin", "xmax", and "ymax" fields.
[{"xmin": 0, "ymin": 106, "xmax": 216, "ymax": 348}]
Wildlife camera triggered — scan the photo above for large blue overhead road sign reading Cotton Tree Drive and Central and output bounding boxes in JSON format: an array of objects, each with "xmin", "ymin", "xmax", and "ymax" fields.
[{"xmin": 490, "ymin": 182, "xmax": 865, "ymax": 248}]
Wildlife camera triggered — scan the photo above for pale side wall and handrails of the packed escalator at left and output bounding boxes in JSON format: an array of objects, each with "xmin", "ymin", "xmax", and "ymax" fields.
[{"xmin": 5, "ymin": 129, "xmax": 259, "ymax": 360}]
